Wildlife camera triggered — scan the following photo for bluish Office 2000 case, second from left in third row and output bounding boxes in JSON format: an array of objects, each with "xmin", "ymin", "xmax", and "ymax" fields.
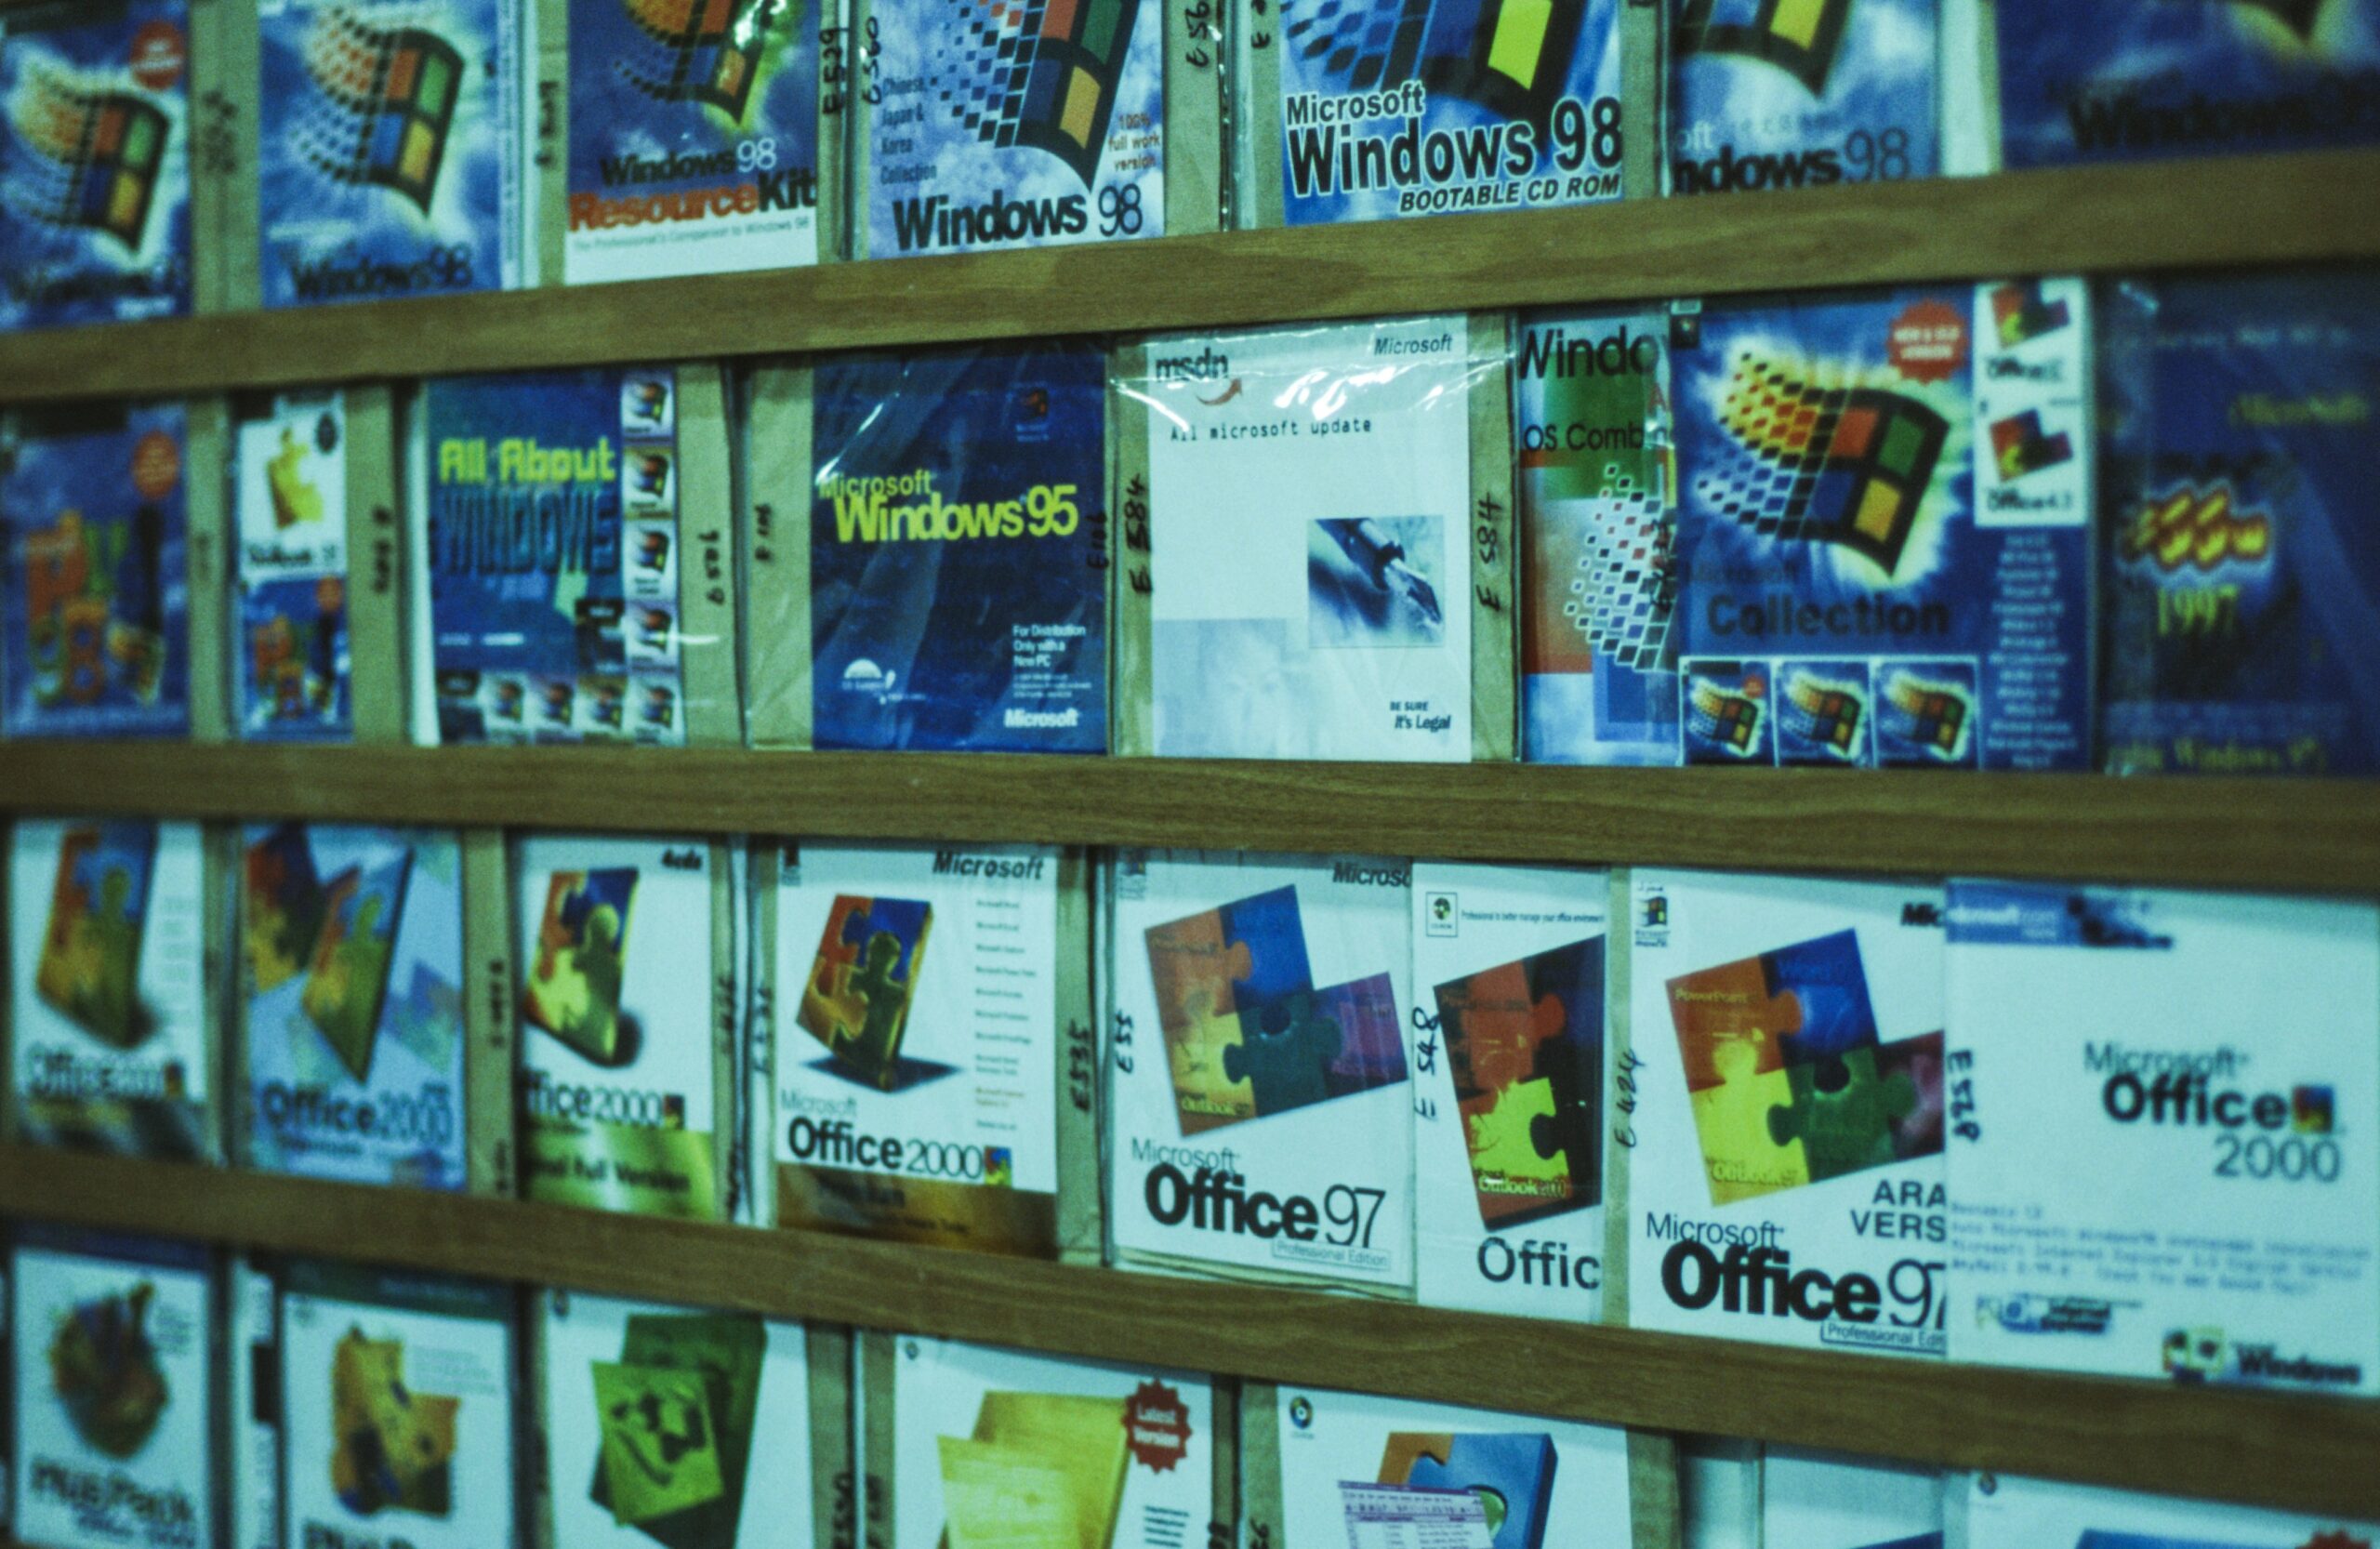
[{"xmin": 235, "ymin": 823, "xmax": 511, "ymax": 1192}]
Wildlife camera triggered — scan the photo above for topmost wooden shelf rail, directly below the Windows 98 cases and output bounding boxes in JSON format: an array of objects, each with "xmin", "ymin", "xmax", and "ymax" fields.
[{"xmin": 0, "ymin": 150, "xmax": 2380, "ymax": 402}]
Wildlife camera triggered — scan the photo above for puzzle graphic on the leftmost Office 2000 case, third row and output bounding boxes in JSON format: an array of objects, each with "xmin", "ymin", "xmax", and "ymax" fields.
[{"xmin": 33, "ymin": 823, "xmax": 158, "ymax": 1056}]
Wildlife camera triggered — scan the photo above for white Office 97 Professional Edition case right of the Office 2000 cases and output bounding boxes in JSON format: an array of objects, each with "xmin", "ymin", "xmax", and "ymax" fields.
[{"xmin": 1102, "ymin": 850, "xmax": 1416, "ymax": 1299}]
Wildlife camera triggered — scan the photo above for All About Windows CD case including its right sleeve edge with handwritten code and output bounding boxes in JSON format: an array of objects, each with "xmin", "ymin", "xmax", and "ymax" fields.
[{"xmin": 409, "ymin": 366, "xmax": 743, "ymax": 748}]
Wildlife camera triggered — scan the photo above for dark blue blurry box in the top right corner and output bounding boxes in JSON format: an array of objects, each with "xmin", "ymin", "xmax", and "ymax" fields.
[{"xmin": 1999, "ymin": 0, "xmax": 2380, "ymax": 166}]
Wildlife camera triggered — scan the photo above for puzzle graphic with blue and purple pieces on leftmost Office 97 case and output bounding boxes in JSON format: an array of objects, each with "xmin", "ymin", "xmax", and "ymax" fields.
[{"xmin": 1144, "ymin": 888, "xmax": 1407, "ymax": 1135}]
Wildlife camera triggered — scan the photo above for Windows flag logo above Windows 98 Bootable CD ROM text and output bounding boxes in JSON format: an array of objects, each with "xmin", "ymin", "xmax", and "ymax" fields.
[{"xmin": 1288, "ymin": 0, "xmax": 1588, "ymax": 128}]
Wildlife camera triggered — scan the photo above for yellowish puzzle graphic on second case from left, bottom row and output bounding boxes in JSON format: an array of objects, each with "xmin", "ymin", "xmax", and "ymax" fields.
[{"xmin": 331, "ymin": 1328, "xmax": 462, "ymax": 1516}]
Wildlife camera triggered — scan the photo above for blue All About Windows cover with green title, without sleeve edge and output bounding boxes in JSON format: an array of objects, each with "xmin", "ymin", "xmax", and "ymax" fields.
[{"xmin": 416, "ymin": 369, "xmax": 690, "ymax": 745}]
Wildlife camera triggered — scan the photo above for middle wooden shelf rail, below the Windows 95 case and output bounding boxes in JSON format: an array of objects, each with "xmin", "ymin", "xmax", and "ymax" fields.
[{"xmin": 0, "ymin": 742, "xmax": 2380, "ymax": 893}]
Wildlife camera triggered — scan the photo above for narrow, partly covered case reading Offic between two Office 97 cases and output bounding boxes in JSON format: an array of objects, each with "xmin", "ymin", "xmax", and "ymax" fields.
[{"xmin": 1409, "ymin": 861, "xmax": 1614, "ymax": 1323}]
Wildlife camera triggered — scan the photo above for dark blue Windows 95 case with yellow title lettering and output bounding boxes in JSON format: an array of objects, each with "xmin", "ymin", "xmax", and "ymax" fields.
[{"xmin": 809, "ymin": 345, "xmax": 1109, "ymax": 752}]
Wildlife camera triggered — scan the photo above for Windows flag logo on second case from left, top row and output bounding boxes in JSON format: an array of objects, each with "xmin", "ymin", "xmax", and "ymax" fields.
[{"xmin": 298, "ymin": 9, "xmax": 464, "ymax": 214}]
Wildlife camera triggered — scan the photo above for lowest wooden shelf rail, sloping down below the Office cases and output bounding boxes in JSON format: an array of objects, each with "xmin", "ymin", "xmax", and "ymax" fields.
[{"xmin": 0, "ymin": 1149, "xmax": 2380, "ymax": 1518}]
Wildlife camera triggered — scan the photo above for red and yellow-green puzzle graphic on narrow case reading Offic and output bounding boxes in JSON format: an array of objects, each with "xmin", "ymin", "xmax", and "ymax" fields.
[{"xmin": 1435, "ymin": 940, "xmax": 1604, "ymax": 1228}]
